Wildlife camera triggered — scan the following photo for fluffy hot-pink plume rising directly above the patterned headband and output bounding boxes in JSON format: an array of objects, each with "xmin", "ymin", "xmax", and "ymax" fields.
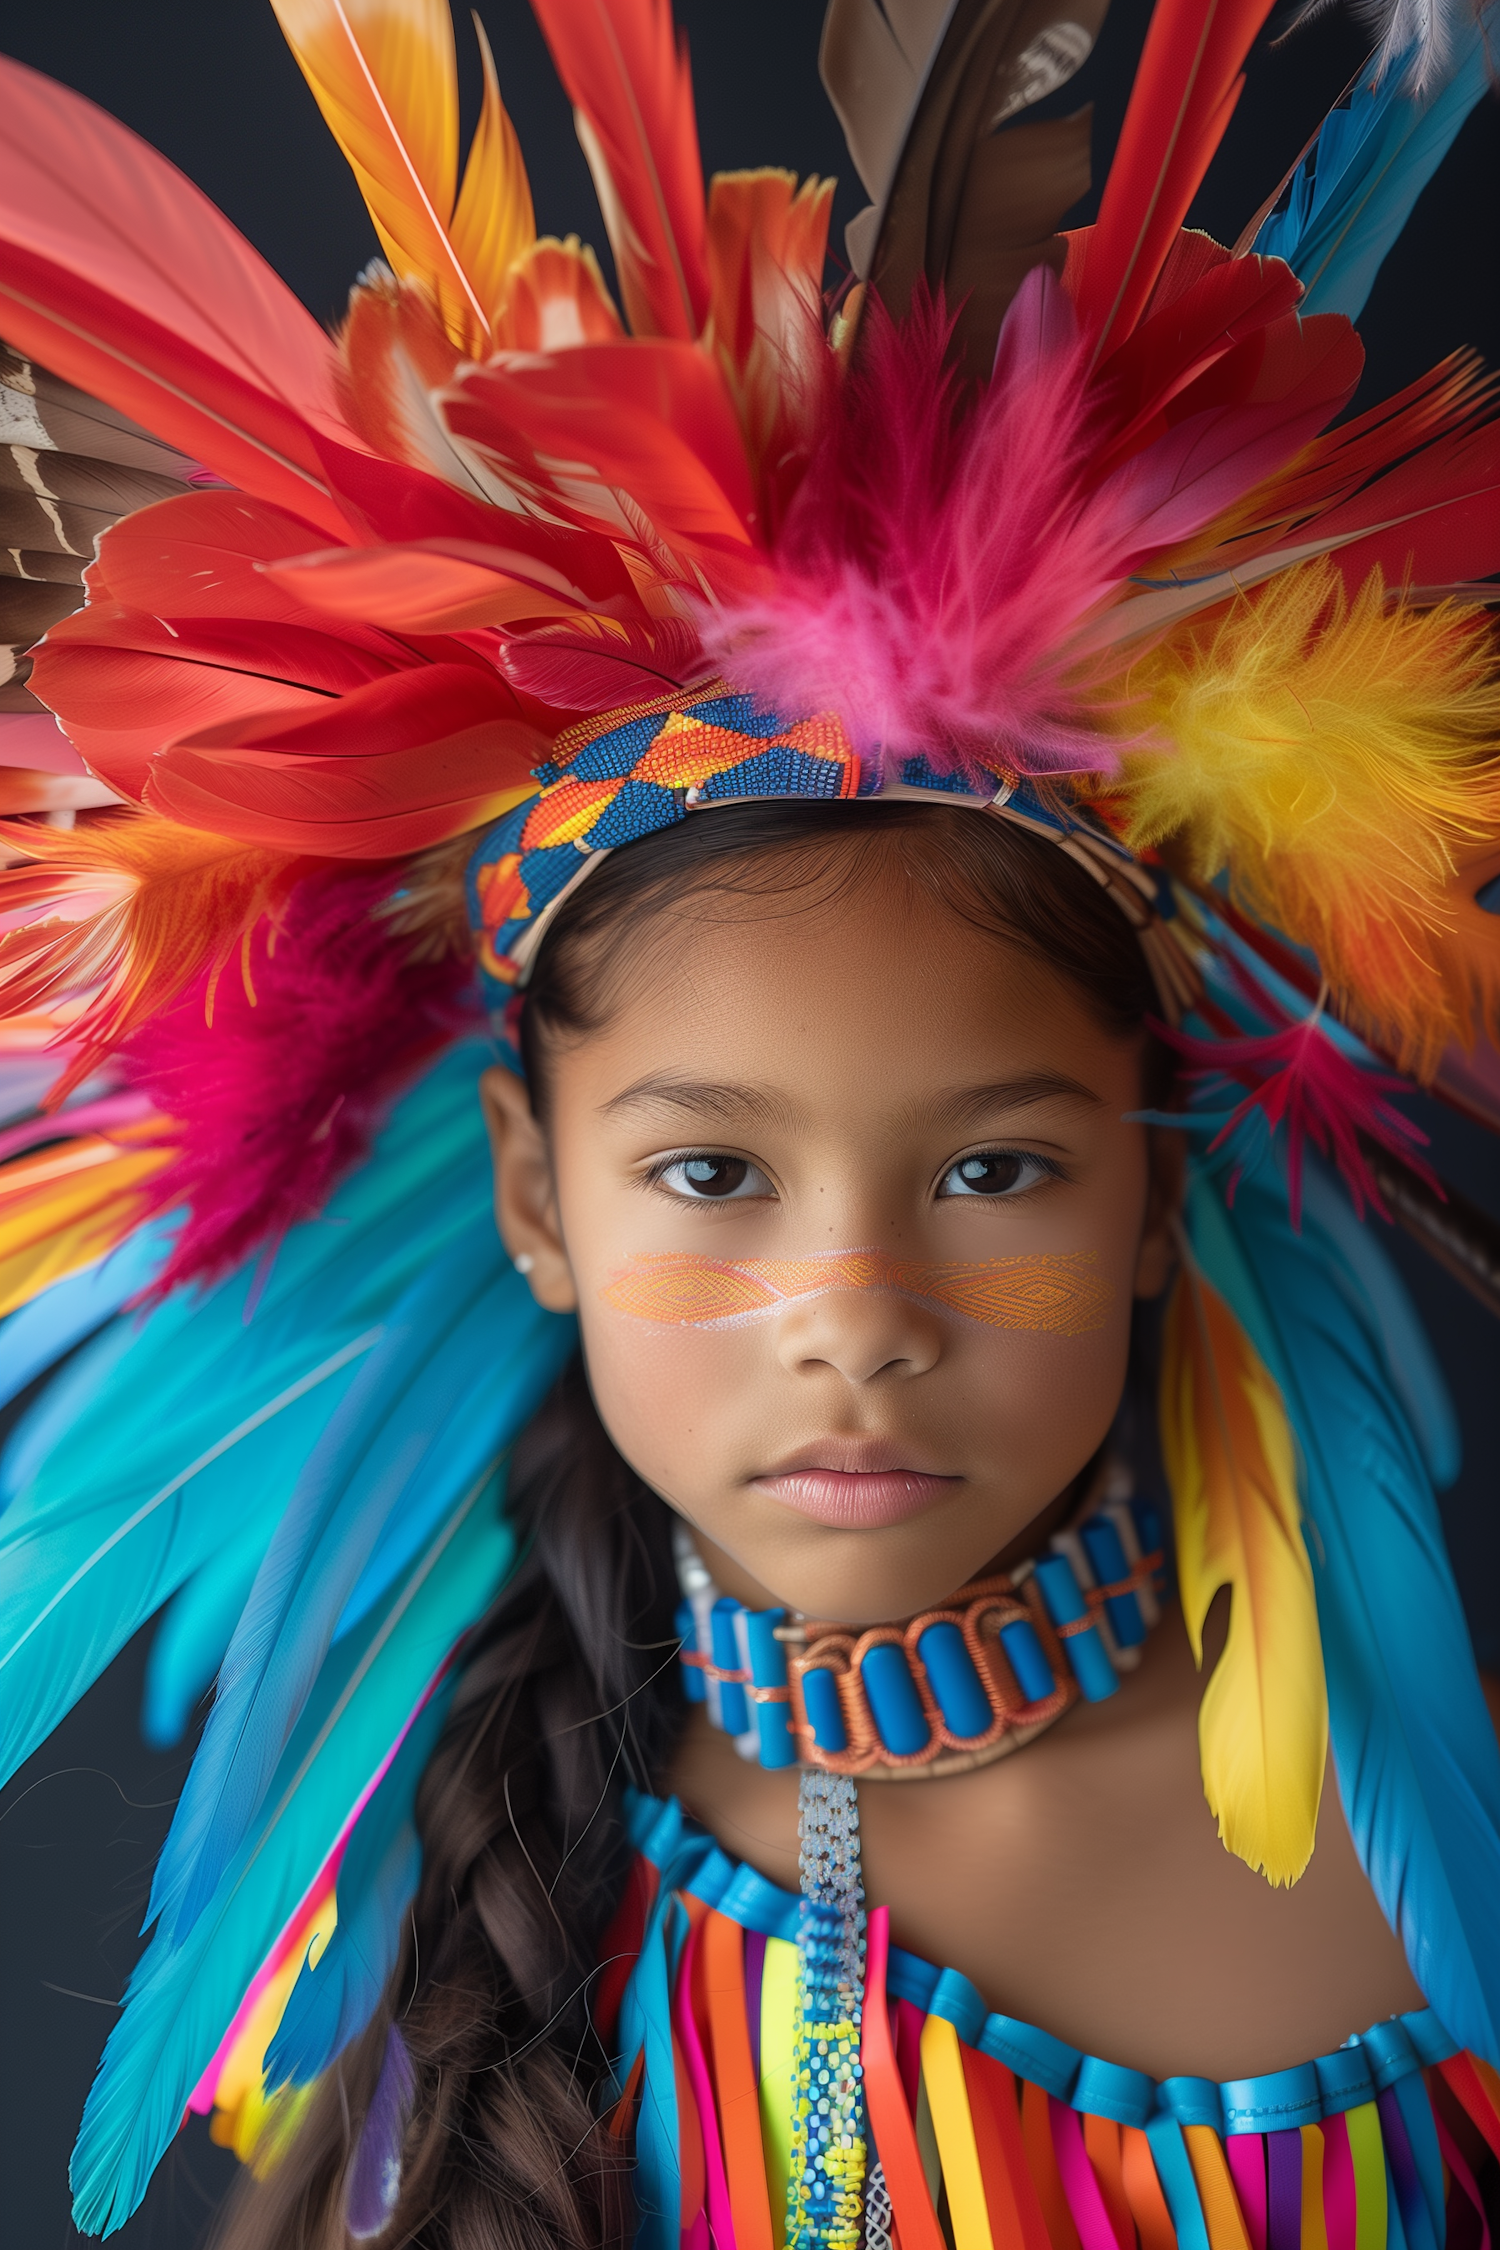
[{"xmin": 699, "ymin": 266, "xmax": 1325, "ymax": 774}]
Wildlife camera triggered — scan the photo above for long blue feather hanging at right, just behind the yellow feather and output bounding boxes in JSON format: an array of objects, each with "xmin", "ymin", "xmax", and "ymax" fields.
[{"xmin": 1190, "ymin": 1161, "xmax": 1500, "ymax": 2066}]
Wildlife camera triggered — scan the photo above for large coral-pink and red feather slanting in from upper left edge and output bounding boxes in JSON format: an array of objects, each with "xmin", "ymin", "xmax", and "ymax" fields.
[{"xmin": 0, "ymin": 59, "xmax": 346, "ymax": 538}]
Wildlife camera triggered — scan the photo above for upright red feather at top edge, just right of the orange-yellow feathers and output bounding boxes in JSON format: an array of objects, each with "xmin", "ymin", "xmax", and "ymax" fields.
[{"xmin": 533, "ymin": 0, "xmax": 708, "ymax": 342}]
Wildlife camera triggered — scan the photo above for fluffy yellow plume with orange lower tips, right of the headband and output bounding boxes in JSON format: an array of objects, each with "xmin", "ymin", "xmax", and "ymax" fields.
[{"xmin": 1113, "ymin": 560, "xmax": 1500, "ymax": 1076}]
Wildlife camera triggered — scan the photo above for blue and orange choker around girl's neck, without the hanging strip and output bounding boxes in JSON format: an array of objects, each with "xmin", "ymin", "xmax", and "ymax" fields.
[{"xmin": 677, "ymin": 1465, "xmax": 1167, "ymax": 1780}]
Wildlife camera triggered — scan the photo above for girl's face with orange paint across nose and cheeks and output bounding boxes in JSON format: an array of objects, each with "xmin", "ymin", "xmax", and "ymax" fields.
[{"xmin": 486, "ymin": 871, "xmax": 1169, "ymax": 1622}]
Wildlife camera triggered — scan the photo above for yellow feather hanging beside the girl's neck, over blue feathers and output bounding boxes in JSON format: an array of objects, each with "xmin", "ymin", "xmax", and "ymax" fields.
[{"xmin": 1160, "ymin": 1269, "xmax": 1329, "ymax": 1883}]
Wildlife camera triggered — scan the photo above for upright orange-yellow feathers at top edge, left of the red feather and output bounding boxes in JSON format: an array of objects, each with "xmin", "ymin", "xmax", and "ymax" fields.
[{"xmin": 272, "ymin": 0, "xmax": 535, "ymax": 358}]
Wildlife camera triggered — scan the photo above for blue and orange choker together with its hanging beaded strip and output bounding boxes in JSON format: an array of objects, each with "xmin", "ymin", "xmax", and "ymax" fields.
[{"xmin": 675, "ymin": 1463, "xmax": 1165, "ymax": 2250}]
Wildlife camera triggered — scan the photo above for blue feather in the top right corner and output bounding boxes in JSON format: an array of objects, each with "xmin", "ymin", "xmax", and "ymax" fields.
[{"xmin": 1255, "ymin": 7, "xmax": 1500, "ymax": 320}]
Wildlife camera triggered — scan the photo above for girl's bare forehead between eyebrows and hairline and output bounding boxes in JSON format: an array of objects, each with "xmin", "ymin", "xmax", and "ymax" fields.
[{"xmin": 546, "ymin": 866, "xmax": 1138, "ymax": 1112}]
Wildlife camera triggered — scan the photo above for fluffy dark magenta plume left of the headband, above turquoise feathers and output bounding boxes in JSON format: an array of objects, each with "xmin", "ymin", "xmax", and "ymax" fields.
[{"xmin": 121, "ymin": 869, "xmax": 477, "ymax": 1296}]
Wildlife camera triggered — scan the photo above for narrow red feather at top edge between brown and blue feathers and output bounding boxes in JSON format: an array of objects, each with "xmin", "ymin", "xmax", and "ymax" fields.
[{"xmin": 1077, "ymin": 0, "xmax": 1271, "ymax": 353}]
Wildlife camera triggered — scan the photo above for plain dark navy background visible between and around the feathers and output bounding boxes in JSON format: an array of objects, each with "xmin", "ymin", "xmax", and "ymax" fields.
[{"xmin": 0, "ymin": 0, "xmax": 1500, "ymax": 2250}]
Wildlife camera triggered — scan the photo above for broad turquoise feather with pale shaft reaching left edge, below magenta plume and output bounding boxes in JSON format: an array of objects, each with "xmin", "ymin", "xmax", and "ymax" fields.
[{"xmin": 0, "ymin": 1042, "xmax": 537, "ymax": 1773}]
